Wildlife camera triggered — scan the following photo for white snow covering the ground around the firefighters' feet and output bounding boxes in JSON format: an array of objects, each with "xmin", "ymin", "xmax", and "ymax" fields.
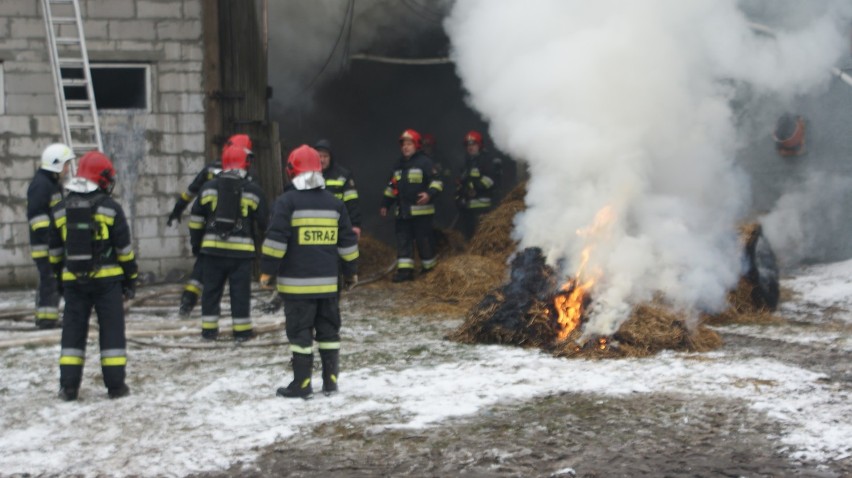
[{"xmin": 0, "ymin": 261, "xmax": 852, "ymax": 476}]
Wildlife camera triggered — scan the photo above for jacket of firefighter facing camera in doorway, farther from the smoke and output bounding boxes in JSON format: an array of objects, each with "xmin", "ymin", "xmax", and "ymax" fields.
[{"xmin": 383, "ymin": 151, "xmax": 444, "ymax": 219}]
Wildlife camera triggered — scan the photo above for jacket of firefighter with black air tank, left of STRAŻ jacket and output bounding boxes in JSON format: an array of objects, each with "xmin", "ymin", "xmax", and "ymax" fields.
[{"xmin": 189, "ymin": 176, "xmax": 269, "ymax": 258}]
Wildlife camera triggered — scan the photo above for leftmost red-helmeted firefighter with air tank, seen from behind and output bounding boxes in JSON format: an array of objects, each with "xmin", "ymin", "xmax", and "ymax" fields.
[{"xmin": 50, "ymin": 151, "xmax": 137, "ymax": 401}]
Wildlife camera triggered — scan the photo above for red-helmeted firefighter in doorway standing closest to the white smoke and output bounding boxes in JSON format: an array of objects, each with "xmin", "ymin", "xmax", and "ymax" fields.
[{"xmin": 455, "ymin": 131, "xmax": 502, "ymax": 240}]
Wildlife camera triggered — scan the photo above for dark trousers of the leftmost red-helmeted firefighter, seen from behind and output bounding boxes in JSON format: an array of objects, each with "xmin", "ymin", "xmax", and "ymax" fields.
[{"xmin": 59, "ymin": 280, "xmax": 127, "ymax": 388}]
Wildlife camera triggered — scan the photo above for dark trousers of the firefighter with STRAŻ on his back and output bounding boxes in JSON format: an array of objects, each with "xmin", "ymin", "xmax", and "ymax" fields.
[{"xmin": 284, "ymin": 296, "xmax": 340, "ymax": 353}]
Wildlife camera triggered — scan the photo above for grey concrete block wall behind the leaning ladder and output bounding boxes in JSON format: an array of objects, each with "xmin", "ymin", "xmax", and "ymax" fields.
[{"xmin": 0, "ymin": 0, "xmax": 209, "ymax": 287}]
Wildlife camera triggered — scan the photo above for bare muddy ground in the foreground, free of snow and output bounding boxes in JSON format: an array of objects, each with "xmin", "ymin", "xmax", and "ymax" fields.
[{"xmin": 196, "ymin": 287, "xmax": 852, "ymax": 478}]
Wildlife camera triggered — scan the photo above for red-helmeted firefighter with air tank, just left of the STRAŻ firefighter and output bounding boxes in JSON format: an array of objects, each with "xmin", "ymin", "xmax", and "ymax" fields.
[{"xmin": 189, "ymin": 145, "xmax": 269, "ymax": 342}]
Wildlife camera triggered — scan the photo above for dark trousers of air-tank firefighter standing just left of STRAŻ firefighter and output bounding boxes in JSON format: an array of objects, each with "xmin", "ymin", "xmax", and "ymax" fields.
[{"xmin": 199, "ymin": 254, "xmax": 252, "ymax": 332}]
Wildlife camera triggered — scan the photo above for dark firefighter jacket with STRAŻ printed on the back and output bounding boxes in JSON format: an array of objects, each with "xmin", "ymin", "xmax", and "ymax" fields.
[{"xmin": 261, "ymin": 188, "xmax": 358, "ymax": 300}]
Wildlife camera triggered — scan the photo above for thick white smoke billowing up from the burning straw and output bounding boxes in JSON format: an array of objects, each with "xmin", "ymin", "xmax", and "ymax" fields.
[{"xmin": 445, "ymin": 0, "xmax": 846, "ymax": 334}]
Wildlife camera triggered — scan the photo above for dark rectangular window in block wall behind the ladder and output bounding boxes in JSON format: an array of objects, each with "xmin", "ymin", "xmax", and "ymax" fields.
[{"xmin": 62, "ymin": 63, "xmax": 151, "ymax": 111}]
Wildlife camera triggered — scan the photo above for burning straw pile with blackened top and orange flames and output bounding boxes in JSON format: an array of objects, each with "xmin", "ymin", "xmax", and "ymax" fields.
[{"xmin": 450, "ymin": 248, "xmax": 722, "ymax": 357}]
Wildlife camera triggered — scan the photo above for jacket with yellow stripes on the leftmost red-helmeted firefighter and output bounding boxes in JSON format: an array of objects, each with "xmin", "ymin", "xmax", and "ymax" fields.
[{"xmin": 50, "ymin": 191, "xmax": 138, "ymax": 282}]
